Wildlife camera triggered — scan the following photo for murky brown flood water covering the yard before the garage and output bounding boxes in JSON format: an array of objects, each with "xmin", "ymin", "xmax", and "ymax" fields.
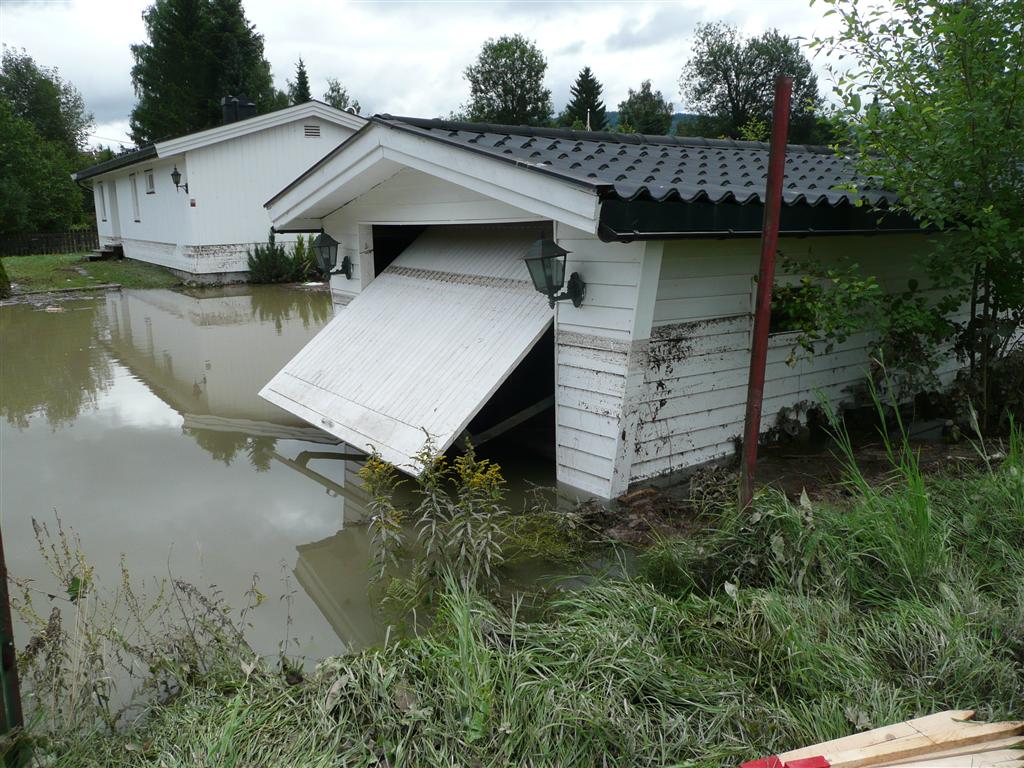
[{"xmin": 0, "ymin": 287, "xmax": 554, "ymax": 659}]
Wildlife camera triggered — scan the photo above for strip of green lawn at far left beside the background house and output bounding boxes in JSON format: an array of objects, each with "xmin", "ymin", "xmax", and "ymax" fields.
[{"xmin": 3, "ymin": 253, "xmax": 180, "ymax": 293}]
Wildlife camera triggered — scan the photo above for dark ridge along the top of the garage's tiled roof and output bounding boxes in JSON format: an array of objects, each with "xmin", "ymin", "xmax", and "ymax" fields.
[{"xmin": 371, "ymin": 113, "xmax": 836, "ymax": 155}]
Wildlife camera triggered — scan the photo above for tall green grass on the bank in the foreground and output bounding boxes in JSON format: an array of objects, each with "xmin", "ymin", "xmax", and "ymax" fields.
[{"xmin": 28, "ymin": 421, "xmax": 1024, "ymax": 768}]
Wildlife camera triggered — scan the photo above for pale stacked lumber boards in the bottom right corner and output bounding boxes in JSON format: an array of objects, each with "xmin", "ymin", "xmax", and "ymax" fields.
[{"xmin": 740, "ymin": 710, "xmax": 1024, "ymax": 768}]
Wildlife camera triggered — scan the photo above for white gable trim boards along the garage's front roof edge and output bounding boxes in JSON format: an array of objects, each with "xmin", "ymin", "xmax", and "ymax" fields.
[{"xmin": 266, "ymin": 119, "xmax": 601, "ymax": 232}]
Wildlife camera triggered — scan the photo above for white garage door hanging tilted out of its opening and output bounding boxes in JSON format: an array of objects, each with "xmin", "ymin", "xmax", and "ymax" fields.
[{"xmin": 260, "ymin": 227, "xmax": 553, "ymax": 471}]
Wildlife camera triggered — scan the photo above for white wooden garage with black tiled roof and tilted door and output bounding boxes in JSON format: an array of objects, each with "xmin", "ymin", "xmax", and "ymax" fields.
[{"xmin": 261, "ymin": 116, "xmax": 953, "ymax": 498}]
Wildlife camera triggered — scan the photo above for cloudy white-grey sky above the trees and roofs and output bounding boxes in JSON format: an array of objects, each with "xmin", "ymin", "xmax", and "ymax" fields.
[{"xmin": 0, "ymin": 0, "xmax": 830, "ymax": 143}]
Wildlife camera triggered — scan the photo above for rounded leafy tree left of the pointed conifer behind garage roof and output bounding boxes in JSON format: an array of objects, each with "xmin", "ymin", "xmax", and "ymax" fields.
[{"xmin": 465, "ymin": 35, "xmax": 552, "ymax": 125}]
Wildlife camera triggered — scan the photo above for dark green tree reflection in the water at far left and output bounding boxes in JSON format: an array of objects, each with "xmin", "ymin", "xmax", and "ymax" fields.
[{"xmin": 0, "ymin": 299, "xmax": 111, "ymax": 429}]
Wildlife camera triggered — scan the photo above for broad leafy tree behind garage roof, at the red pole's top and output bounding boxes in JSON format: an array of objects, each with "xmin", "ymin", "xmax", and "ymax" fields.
[{"xmin": 679, "ymin": 23, "xmax": 829, "ymax": 143}]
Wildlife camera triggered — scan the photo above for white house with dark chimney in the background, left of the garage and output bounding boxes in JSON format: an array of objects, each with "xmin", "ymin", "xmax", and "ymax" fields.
[{"xmin": 74, "ymin": 99, "xmax": 366, "ymax": 283}]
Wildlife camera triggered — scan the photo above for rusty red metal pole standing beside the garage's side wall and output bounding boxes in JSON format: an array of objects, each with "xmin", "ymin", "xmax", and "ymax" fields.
[{"xmin": 739, "ymin": 76, "xmax": 793, "ymax": 509}]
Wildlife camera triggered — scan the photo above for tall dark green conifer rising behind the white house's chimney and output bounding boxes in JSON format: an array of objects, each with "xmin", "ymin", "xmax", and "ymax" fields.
[{"xmin": 131, "ymin": 0, "xmax": 287, "ymax": 144}]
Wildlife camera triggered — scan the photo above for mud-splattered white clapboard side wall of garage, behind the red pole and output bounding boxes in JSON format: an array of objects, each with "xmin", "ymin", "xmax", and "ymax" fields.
[{"xmin": 628, "ymin": 236, "xmax": 956, "ymax": 481}]
